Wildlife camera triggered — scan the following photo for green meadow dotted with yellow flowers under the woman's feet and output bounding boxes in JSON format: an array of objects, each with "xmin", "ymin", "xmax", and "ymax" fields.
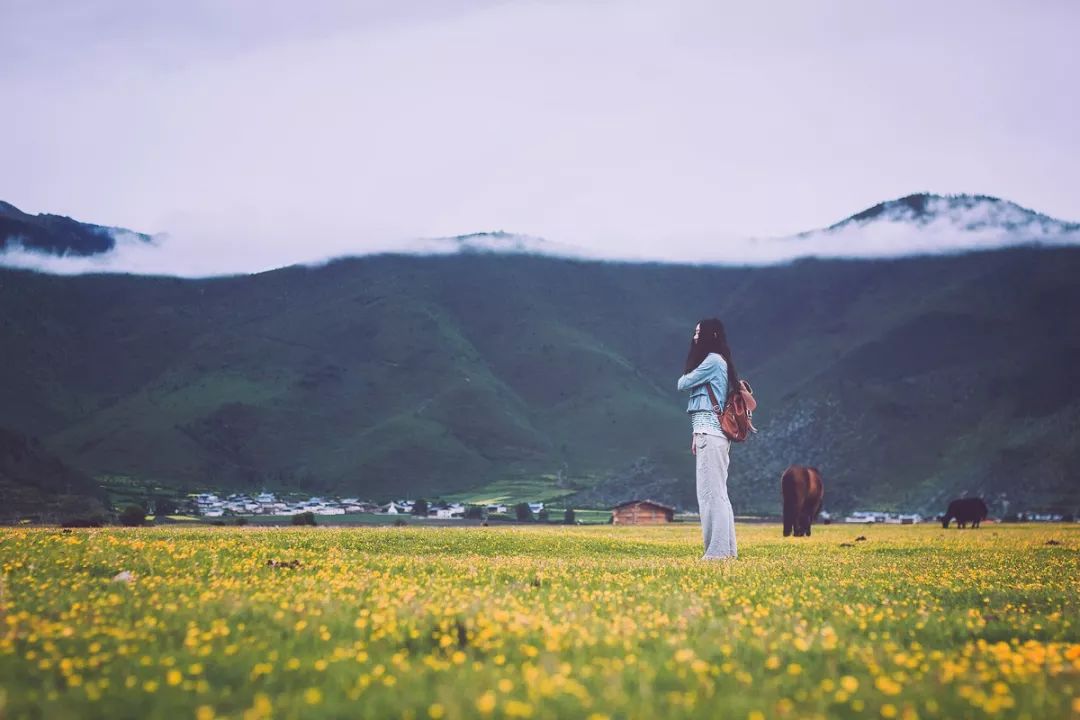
[{"xmin": 0, "ymin": 524, "xmax": 1080, "ymax": 720}]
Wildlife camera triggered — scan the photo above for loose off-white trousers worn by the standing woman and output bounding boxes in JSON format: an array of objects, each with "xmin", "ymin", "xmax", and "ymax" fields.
[{"xmin": 693, "ymin": 433, "xmax": 738, "ymax": 559}]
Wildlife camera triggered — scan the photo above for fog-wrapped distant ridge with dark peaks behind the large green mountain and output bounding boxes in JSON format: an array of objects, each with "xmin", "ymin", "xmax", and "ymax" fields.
[{"xmin": 0, "ymin": 193, "xmax": 1080, "ymax": 276}]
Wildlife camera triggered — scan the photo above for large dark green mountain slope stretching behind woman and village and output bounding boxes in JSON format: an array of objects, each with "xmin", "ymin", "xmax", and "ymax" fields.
[{"xmin": 0, "ymin": 247, "xmax": 1080, "ymax": 513}]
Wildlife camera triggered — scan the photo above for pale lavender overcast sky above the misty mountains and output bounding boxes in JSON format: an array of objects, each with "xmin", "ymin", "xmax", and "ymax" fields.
[{"xmin": 0, "ymin": 0, "xmax": 1080, "ymax": 273}]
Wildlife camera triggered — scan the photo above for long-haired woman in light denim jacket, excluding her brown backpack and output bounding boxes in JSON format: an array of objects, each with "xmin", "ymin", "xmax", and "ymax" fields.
[{"xmin": 678, "ymin": 317, "xmax": 738, "ymax": 560}]
